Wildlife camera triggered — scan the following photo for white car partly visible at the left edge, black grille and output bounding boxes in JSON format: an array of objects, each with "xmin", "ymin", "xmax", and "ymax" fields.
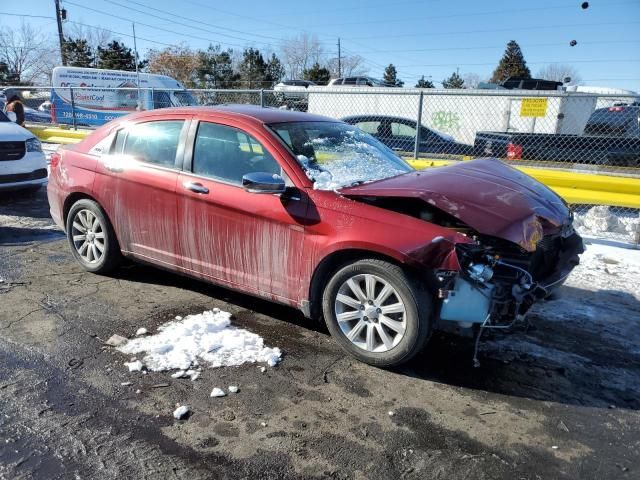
[{"xmin": 0, "ymin": 112, "xmax": 47, "ymax": 191}]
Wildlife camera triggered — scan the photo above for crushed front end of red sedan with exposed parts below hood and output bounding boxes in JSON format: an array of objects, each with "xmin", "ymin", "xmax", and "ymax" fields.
[{"xmin": 436, "ymin": 223, "xmax": 584, "ymax": 330}]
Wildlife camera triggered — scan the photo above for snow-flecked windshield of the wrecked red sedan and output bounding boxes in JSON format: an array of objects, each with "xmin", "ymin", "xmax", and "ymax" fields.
[{"xmin": 270, "ymin": 122, "xmax": 413, "ymax": 190}]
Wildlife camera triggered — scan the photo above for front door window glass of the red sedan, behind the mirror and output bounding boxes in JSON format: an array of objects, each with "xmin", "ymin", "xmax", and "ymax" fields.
[{"xmin": 192, "ymin": 122, "xmax": 282, "ymax": 185}]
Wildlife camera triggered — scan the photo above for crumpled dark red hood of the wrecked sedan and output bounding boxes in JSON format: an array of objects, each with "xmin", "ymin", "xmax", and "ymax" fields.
[{"xmin": 340, "ymin": 158, "xmax": 570, "ymax": 251}]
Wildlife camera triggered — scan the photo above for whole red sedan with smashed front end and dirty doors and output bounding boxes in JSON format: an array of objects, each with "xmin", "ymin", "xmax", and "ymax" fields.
[{"xmin": 48, "ymin": 106, "xmax": 582, "ymax": 366}]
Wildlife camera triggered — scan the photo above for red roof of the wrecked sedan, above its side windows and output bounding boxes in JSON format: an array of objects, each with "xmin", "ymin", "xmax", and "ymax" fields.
[{"xmin": 122, "ymin": 105, "xmax": 339, "ymax": 124}]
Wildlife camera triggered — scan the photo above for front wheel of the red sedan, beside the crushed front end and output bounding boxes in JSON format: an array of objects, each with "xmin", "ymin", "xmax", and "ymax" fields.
[{"xmin": 322, "ymin": 259, "xmax": 432, "ymax": 367}]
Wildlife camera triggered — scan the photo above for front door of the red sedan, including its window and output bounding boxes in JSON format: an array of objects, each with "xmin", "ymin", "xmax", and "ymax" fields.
[{"xmin": 178, "ymin": 121, "xmax": 307, "ymax": 301}]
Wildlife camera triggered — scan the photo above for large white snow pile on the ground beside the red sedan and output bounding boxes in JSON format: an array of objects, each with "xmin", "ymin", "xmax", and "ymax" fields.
[{"xmin": 118, "ymin": 308, "xmax": 281, "ymax": 374}]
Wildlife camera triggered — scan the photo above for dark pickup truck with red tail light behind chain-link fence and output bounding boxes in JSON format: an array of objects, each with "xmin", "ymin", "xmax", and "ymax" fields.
[{"xmin": 474, "ymin": 103, "xmax": 640, "ymax": 167}]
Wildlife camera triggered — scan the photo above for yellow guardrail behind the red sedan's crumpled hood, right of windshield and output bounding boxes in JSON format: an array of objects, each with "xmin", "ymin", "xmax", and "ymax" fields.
[{"xmin": 406, "ymin": 158, "xmax": 640, "ymax": 208}]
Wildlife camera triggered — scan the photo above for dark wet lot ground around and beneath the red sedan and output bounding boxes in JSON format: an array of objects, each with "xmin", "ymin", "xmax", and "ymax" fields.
[{"xmin": 0, "ymin": 191, "xmax": 640, "ymax": 480}]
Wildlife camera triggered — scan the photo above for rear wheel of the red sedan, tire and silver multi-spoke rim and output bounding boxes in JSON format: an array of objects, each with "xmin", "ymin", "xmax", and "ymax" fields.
[{"xmin": 67, "ymin": 199, "xmax": 122, "ymax": 274}]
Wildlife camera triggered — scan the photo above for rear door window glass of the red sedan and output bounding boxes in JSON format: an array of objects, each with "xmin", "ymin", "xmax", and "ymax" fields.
[{"xmin": 119, "ymin": 120, "xmax": 184, "ymax": 168}]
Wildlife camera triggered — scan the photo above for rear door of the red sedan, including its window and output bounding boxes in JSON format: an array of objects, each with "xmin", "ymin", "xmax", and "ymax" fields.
[{"xmin": 94, "ymin": 117, "xmax": 189, "ymax": 267}]
